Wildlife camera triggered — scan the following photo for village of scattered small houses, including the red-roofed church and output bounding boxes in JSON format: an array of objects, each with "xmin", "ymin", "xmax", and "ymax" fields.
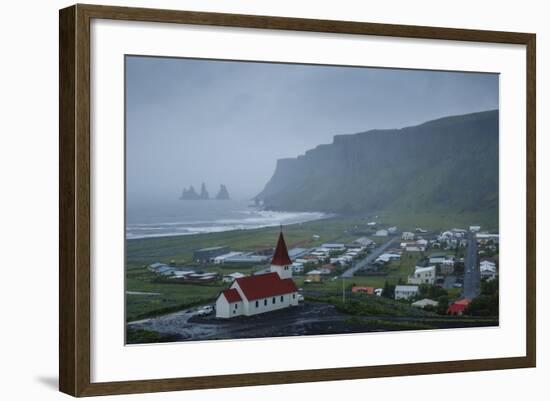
[{"xmin": 127, "ymin": 217, "xmax": 499, "ymax": 339}]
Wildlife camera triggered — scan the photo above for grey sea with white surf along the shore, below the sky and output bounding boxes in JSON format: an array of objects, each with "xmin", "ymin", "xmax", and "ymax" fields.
[{"xmin": 126, "ymin": 200, "xmax": 328, "ymax": 239}]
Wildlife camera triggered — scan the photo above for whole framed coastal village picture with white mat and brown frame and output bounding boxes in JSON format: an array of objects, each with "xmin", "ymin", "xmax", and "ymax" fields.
[{"xmin": 59, "ymin": 5, "xmax": 536, "ymax": 396}]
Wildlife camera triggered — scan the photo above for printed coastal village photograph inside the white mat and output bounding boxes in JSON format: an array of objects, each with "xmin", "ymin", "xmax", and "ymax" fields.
[{"xmin": 123, "ymin": 54, "xmax": 500, "ymax": 345}]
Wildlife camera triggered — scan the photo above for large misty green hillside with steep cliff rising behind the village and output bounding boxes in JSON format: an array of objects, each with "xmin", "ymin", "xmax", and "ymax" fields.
[{"xmin": 257, "ymin": 111, "xmax": 498, "ymax": 225}]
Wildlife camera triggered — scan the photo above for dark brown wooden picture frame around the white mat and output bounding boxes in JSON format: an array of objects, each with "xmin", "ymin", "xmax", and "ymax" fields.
[{"xmin": 59, "ymin": 4, "xmax": 536, "ymax": 396}]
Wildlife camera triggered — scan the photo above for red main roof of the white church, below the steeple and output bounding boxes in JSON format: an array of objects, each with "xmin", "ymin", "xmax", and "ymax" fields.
[{"xmin": 235, "ymin": 272, "xmax": 298, "ymax": 301}]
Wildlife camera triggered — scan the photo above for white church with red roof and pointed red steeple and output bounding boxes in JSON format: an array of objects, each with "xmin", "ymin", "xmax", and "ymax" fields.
[{"xmin": 216, "ymin": 228, "xmax": 298, "ymax": 319}]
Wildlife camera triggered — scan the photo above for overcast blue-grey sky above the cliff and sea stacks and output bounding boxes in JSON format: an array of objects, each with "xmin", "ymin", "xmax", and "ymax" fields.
[{"xmin": 126, "ymin": 56, "xmax": 498, "ymax": 201}]
